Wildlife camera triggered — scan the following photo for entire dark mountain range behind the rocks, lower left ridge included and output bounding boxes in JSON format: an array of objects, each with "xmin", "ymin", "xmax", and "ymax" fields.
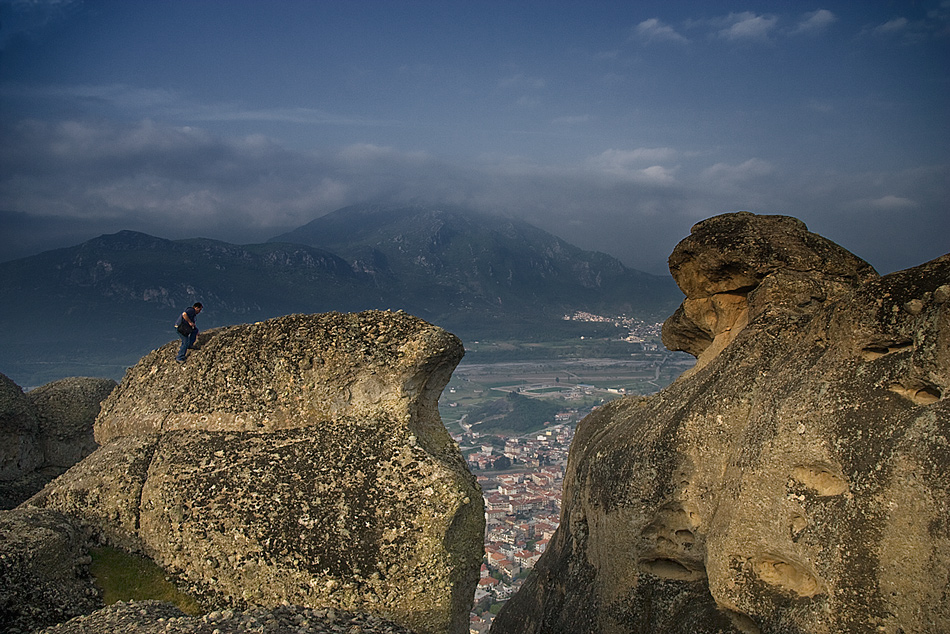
[{"xmin": 0, "ymin": 207, "xmax": 681, "ymax": 386}]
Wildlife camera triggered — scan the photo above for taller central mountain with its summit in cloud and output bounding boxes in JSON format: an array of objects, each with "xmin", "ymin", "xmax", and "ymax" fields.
[{"xmin": 272, "ymin": 205, "xmax": 679, "ymax": 322}]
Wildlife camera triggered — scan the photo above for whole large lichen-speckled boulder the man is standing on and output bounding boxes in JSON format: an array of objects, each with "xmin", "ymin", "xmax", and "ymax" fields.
[{"xmin": 29, "ymin": 311, "xmax": 484, "ymax": 632}]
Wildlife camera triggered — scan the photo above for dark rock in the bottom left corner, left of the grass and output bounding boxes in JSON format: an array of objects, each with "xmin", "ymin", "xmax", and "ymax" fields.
[{"xmin": 0, "ymin": 508, "xmax": 102, "ymax": 633}]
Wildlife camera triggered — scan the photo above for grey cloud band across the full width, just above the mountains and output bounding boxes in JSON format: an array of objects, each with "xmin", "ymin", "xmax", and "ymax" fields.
[{"xmin": 0, "ymin": 120, "xmax": 950, "ymax": 273}]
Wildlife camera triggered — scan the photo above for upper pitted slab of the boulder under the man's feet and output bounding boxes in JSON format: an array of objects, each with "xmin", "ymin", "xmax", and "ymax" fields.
[{"xmin": 96, "ymin": 311, "xmax": 464, "ymax": 446}]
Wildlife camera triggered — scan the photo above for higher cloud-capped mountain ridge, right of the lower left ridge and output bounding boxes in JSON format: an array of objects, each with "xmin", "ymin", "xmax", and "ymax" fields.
[{"xmin": 272, "ymin": 205, "xmax": 665, "ymax": 317}]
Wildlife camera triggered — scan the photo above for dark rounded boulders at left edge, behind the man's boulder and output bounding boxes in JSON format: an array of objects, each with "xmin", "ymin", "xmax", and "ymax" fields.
[{"xmin": 0, "ymin": 374, "xmax": 116, "ymax": 509}]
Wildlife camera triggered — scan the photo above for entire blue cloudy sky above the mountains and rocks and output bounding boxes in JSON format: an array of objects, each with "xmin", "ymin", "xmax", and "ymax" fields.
[{"xmin": 0, "ymin": 0, "xmax": 950, "ymax": 274}]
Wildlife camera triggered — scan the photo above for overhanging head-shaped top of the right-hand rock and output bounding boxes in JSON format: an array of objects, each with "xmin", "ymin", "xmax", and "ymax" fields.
[{"xmin": 663, "ymin": 212, "xmax": 877, "ymax": 373}]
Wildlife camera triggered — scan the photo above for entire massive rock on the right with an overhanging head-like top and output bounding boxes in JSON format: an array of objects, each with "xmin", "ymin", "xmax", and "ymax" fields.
[{"xmin": 492, "ymin": 213, "xmax": 950, "ymax": 634}]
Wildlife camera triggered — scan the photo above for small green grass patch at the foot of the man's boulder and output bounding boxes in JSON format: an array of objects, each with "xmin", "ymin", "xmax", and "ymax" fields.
[{"xmin": 90, "ymin": 546, "xmax": 204, "ymax": 616}]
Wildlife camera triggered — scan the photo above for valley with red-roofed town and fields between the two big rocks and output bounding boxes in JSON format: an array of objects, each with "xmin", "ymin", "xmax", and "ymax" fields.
[{"xmin": 439, "ymin": 313, "xmax": 694, "ymax": 634}]
